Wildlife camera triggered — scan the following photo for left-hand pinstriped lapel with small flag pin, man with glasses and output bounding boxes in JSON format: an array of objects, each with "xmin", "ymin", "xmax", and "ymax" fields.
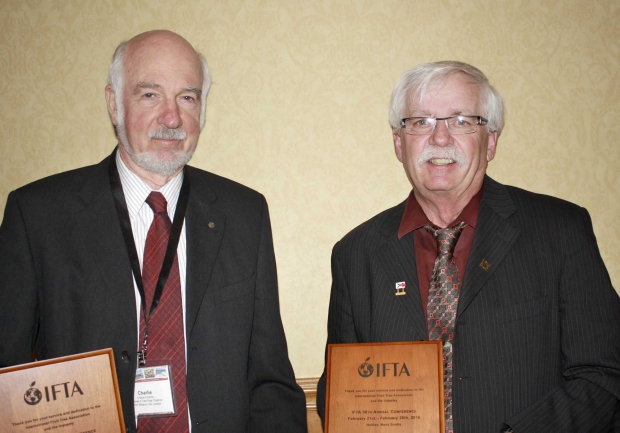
[{"xmin": 373, "ymin": 203, "xmax": 428, "ymax": 339}]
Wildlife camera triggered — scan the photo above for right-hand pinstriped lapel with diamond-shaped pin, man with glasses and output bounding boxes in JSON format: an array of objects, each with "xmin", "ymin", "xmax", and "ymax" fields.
[{"xmin": 458, "ymin": 177, "xmax": 519, "ymax": 315}]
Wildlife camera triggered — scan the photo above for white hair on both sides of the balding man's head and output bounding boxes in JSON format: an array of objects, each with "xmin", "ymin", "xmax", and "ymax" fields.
[{"xmin": 108, "ymin": 41, "xmax": 211, "ymax": 130}]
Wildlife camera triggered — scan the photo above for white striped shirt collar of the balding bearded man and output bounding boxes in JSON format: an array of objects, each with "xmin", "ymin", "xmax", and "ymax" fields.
[{"xmin": 116, "ymin": 151, "xmax": 184, "ymax": 220}]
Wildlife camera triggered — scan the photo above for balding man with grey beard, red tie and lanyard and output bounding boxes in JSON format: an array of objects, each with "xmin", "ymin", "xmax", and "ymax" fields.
[{"xmin": 0, "ymin": 30, "xmax": 306, "ymax": 433}]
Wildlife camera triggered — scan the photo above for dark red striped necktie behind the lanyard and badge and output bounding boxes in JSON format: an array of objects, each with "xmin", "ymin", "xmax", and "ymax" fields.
[{"xmin": 138, "ymin": 191, "xmax": 189, "ymax": 433}]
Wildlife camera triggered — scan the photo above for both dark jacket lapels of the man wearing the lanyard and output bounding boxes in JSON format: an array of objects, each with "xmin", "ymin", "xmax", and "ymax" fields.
[{"xmin": 73, "ymin": 158, "xmax": 226, "ymax": 340}]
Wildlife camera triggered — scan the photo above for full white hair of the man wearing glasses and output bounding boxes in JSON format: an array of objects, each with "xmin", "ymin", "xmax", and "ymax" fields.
[{"xmin": 389, "ymin": 61, "xmax": 505, "ymax": 135}]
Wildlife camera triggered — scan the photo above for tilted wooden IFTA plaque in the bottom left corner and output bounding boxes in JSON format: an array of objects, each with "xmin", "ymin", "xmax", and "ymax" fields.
[{"xmin": 0, "ymin": 349, "xmax": 125, "ymax": 433}]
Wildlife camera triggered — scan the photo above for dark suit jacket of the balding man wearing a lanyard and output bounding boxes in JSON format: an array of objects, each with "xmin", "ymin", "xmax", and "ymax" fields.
[{"xmin": 0, "ymin": 151, "xmax": 306, "ymax": 433}]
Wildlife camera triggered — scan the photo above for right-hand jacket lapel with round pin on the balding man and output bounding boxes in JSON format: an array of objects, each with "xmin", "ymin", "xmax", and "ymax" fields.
[{"xmin": 185, "ymin": 167, "xmax": 226, "ymax": 336}]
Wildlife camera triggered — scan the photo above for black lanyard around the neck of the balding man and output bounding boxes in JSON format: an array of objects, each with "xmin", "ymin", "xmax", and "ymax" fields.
[{"xmin": 108, "ymin": 150, "xmax": 189, "ymax": 365}]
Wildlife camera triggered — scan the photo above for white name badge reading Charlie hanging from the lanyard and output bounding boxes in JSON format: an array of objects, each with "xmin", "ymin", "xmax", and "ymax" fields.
[{"xmin": 133, "ymin": 365, "xmax": 176, "ymax": 418}]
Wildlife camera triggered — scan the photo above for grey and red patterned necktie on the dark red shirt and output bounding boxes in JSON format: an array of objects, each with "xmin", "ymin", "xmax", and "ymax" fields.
[{"xmin": 424, "ymin": 222, "xmax": 467, "ymax": 433}]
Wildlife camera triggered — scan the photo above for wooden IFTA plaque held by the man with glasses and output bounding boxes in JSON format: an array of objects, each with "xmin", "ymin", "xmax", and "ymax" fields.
[{"xmin": 325, "ymin": 341, "xmax": 445, "ymax": 433}]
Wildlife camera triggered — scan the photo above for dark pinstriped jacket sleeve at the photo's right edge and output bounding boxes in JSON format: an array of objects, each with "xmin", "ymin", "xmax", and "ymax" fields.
[{"xmin": 506, "ymin": 208, "xmax": 620, "ymax": 433}]
